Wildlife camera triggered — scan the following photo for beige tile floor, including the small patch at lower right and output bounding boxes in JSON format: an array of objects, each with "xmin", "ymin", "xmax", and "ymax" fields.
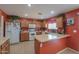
[{"xmin": 10, "ymin": 41, "xmax": 76, "ymax": 54}]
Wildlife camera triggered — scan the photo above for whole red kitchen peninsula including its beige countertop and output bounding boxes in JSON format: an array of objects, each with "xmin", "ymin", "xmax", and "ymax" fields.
[{"xmin": 34, "ymin": 33, "xmax": 69, "ymax": 54}]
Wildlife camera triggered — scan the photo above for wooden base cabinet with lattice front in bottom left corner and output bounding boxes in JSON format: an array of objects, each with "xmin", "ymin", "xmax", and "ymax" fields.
[{"xmin": 0, "ymin": 40, "xmax": 10, "ymax": 54}]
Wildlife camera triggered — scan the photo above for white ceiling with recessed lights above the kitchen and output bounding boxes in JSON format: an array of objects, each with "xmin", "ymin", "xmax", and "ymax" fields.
[{"xmin": 0, "ymin": 4, "xmax": 79, "ymax": 19}]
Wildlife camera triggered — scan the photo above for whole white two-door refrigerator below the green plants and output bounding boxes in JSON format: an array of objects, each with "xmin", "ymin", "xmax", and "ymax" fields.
[{"xmin": 6, "ymin": 22, "xmax": 20, "ymax": 44}]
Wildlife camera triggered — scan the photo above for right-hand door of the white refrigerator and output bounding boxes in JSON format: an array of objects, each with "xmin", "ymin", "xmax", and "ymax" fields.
[{"xmin": 11, "ymin": 23, "xmax": 20, "ymax": 43}]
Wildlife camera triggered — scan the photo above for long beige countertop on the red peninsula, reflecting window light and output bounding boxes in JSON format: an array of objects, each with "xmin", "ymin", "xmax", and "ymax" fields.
[{"xmin": 35, "ymin": 33, "xmax": 70, "ymax": 42}]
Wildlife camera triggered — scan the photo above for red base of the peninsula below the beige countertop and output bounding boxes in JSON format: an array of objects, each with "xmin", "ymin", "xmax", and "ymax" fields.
[{"xmin": 34, "ymin": 38, "xmax": 67, "ymax": 54}]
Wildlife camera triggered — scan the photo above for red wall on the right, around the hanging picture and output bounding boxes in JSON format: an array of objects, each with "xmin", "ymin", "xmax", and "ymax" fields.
[{"xmin": 66, "ymin": 8, "xmax": 79, "ymax": 51}]
